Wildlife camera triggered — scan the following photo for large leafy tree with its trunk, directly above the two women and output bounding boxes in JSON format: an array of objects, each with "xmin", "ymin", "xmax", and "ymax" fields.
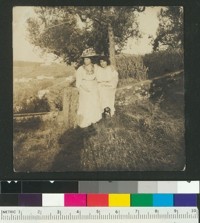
[{"xmin": 27, "ymin": 6, "xmax": 145, "ymax": 65}]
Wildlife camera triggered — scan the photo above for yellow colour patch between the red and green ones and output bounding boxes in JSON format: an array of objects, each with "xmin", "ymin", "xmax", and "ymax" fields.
[{"xmin": 108, "ymin": 194, "xmax": 130, "ymax": 207}]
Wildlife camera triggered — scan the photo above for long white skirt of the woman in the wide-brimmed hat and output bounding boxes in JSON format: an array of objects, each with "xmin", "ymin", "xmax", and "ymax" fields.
[{"xmin": 78, "ymin": 81, "xmax": 102, "ymax": 128}]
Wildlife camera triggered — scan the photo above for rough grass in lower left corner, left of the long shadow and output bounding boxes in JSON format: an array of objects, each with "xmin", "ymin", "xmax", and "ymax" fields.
[{"xmin": 13, "ymin": 118, "xmax": 61, "ymax": 172}]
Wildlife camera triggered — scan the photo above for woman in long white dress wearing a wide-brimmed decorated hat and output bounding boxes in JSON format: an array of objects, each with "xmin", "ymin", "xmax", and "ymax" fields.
[{"xmin": 76, "ymin": 49, "xmax": 102, "ymax": 128}]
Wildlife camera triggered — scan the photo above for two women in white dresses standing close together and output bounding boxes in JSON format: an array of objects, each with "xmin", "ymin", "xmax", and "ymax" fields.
[{"xmin": 76, "ymin": 48, "xmax": 118, "ymax": 128}]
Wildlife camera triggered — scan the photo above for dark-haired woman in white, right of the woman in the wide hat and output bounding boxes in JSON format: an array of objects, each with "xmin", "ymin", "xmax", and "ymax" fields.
[{"xmin": 97, "ymin": 56, "xmax": 118, "ymax": 116}]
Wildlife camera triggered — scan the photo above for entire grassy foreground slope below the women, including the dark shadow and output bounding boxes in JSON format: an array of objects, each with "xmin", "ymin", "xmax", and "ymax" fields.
[{"xmin": 14, "ymin": 74, "xmax": 185, "ymax": 172}]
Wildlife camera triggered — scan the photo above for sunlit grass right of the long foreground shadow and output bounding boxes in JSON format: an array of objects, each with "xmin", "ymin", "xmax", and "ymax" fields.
[{"xmin": 82, "ymin": 97, "xmax": 185, "ymax": 171}]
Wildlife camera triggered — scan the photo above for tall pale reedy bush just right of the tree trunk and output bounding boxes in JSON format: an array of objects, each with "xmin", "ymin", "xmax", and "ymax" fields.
[{"xmin": 116, "ymin": 54, "xmax": 147, "ymax": 80}]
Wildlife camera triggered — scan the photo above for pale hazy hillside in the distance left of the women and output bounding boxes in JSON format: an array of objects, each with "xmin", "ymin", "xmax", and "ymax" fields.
[{"xmin": 13, "ymin": 61, "xmax": 74, "ymax": 112}]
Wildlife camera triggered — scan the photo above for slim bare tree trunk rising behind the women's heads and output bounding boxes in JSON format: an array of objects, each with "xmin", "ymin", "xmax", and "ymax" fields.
[{"xmin": 108, "ymin": 23, "xmax": 116, "ymax": 68}]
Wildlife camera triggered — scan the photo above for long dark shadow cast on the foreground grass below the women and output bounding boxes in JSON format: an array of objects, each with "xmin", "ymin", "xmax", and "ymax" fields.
[{"xmin": 50, "ymin": 126, "xmax": 96, "ymax": 172}]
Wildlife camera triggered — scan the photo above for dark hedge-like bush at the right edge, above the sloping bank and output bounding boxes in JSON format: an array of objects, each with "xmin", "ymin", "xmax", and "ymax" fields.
[{"xmin": 143, "ymin": 50, "xmax": 184, "ymax": 78}]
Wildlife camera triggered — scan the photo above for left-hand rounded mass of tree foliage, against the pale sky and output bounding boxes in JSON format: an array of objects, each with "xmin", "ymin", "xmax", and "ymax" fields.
[{"xmin": 27, "ymin": 7, "xmax": 85, "ymax": 63}]
